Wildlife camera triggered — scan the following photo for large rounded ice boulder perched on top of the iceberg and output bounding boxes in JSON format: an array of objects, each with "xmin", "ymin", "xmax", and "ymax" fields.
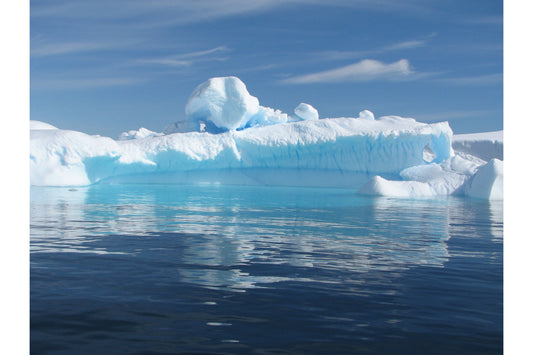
[{"xmin": 185, "ymin": 76, "xmax": 260, "ymax": 131}]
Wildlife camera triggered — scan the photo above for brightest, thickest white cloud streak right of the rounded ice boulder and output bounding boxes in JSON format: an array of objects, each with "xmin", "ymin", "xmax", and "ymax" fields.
[{"xmin": 282, "ymin": 59, "xmax": 415, "ymax": 84}]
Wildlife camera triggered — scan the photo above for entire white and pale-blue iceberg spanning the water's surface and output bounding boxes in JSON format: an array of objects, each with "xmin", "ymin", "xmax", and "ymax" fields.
[{"xmin": 30, "ymin": 77, "xmax": 502, "ymax": 199}]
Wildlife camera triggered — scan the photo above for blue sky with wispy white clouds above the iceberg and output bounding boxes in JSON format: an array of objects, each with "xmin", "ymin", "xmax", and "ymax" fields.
[{"xmin": 30, "ymin": 0, "xmax": 503, "ymax": 137}]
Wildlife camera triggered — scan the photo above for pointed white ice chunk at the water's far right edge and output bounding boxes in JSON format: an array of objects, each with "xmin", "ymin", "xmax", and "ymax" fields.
[{"xmin": 465, "ymin": 159, "xmax": 503, "ymax": 200}]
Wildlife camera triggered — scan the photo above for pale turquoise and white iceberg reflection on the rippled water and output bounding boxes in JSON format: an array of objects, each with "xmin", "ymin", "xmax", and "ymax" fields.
[{"xmin": 31, "ymin": 185, "xmax": 503, "ymax": 290}]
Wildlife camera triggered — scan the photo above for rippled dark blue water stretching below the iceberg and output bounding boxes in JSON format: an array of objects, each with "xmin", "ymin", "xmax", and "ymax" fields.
[{"xmin": 30, "ymin": 185, "xmax": 503, "ymax": 354}]
